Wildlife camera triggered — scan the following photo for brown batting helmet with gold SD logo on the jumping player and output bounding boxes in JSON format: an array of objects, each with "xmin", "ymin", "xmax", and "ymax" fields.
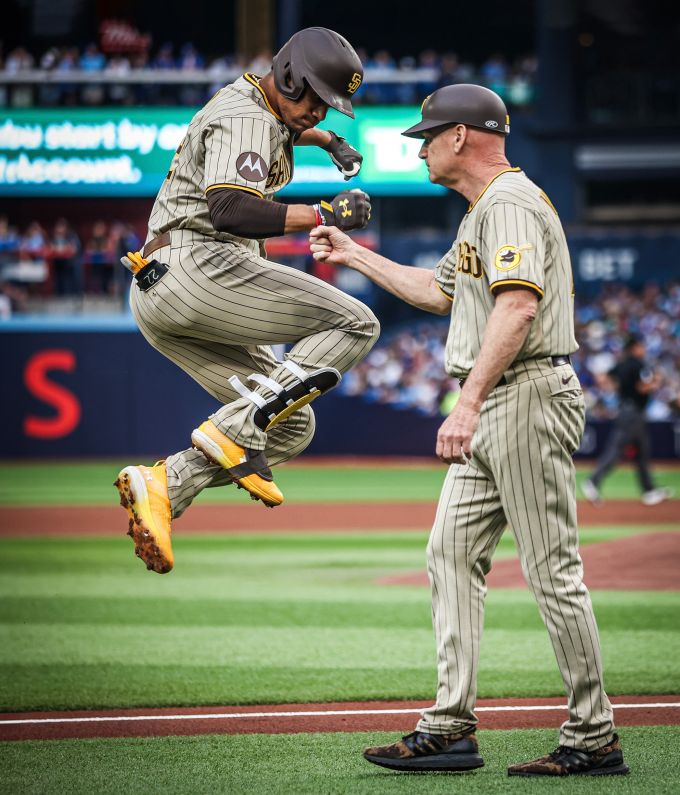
[{"xmin": 272, "ymin": 28, "xmax": 364, "ymax": 118}]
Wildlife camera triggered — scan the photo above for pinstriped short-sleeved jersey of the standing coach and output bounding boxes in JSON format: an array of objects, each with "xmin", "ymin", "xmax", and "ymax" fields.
[{"xmin": 435, "ymin": 168, "xmax": 578, "ymax": 378}]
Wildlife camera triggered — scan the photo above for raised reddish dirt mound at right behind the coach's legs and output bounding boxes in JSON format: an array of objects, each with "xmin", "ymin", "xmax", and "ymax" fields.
[{"xmin": 378, "ymin": 533, "xmax": 680, "ymax": 591}]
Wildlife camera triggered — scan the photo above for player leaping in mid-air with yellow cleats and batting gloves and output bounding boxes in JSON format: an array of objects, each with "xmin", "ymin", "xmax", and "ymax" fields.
[{"xmin": 115, "ymin": 27, "xmax": 379, "ymax": 573}]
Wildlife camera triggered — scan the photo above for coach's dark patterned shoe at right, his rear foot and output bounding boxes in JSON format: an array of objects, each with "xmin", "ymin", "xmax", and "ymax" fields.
[{"xmin": 508, "ymin": 734, "xmax": 630, "ymax": 776}]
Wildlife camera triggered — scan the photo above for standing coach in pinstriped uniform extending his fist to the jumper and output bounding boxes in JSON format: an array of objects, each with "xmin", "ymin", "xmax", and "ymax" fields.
[{"xmin": 311, "ymin": 85, "xmax": 628, "ymax": 776}]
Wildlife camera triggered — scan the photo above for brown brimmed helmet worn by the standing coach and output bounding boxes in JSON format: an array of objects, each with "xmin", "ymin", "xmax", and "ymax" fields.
[{"xmin": 402, "ymin": 83, "xmax": 510, "ymax": 138}]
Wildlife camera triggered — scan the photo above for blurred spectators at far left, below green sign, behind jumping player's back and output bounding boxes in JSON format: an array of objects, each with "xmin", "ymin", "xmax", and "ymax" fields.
[{"xmin": 0, "ymin": 216, "xmax": 141, "ymax": 319}]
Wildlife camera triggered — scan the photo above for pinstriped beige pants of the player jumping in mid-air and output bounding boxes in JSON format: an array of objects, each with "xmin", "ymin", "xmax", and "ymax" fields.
[{"xmin": 130, "ymin": 233, "xmax": 380, "ymax": 517}]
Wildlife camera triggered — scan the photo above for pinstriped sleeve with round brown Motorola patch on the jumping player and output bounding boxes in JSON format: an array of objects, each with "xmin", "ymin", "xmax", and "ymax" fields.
[{"xmin": 203, "ymin": 116, "xmax": 272, "ymax": 198}]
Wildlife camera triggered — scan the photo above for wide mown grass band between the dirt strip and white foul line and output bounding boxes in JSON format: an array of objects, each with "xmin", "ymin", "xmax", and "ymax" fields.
[{"xmin": 0, "ymin": 528, "xmax": 680, "ymax": 710}]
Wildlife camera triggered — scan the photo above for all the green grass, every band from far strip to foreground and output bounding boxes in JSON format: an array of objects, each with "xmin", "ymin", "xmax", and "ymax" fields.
[{"xmin": 0, "ymin": 463, "xmax": 680, "ymax": 793}]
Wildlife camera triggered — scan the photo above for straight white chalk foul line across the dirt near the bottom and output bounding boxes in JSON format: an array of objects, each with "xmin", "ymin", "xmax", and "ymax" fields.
[{"xmin": 0, "ymin": 701, "xmax": 680, "ymax": 726}]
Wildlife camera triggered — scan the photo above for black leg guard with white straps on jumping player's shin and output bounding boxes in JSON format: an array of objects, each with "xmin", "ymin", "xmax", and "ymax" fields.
[{"xmin": 229, "ymin": 359, "xmax": 342, "ymax": 431}]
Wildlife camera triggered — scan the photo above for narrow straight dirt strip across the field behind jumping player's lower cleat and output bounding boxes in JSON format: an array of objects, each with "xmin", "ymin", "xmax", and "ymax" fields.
[{"xmin": 0, "ymin": 500, "xmax": 680, "ymax": 536}]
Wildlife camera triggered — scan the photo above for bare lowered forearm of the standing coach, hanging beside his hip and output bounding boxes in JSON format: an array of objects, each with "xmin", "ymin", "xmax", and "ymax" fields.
[{"xmin": 460, "ymin": 290, "xmax": 537, "ymax": 410}]
